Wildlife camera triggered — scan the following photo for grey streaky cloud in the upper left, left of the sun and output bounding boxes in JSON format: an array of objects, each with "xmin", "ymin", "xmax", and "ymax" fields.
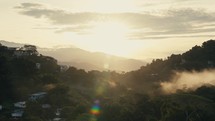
[{"xmin": 15, "ymin": 3, "xmax": 101, "ymax": 25}]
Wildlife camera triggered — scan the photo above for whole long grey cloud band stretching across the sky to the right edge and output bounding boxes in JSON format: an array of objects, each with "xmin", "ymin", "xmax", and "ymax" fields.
[{"xmin": 15, "ymin": 3, "xmax": 215, "ymax": 39}]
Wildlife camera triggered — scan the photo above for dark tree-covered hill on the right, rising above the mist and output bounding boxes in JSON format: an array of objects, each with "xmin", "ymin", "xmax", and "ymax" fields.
[{"xmin": 133, "ymin": 40, "xmax": 215, "ymax": 75}]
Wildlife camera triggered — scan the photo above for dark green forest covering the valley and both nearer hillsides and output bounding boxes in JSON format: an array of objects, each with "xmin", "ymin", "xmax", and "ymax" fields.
[{"xmin": 0, "ymin": 40, "xmax": 215, "ymax": 121}]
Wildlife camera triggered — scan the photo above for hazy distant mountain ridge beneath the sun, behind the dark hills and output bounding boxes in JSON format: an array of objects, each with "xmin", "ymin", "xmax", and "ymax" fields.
[{"xmin": 0, "ymin": 41, "xmax": 146, "ymax": 72}]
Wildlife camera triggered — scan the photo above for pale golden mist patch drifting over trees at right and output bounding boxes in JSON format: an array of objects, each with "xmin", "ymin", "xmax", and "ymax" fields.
[{"xmin": 161, "ymin": 70, "xmax": 215, "ymax": 93}]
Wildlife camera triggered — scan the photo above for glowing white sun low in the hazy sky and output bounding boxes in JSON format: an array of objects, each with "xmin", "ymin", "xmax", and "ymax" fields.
[{"xmin": 89, "ymin": 22, "xmax": 129, "ymax": 55}]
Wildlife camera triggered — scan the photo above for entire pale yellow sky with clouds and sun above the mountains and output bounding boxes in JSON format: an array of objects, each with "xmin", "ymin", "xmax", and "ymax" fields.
[{"xmin": 0, "ymin": 0, "xmax": 215, "ymax": 60}]
